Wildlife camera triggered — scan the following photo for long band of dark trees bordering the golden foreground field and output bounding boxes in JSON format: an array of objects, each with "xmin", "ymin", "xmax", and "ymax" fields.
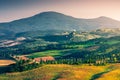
[{"xmin": 0, "ymin": 51, "xmax": 120, "ymax": 73}]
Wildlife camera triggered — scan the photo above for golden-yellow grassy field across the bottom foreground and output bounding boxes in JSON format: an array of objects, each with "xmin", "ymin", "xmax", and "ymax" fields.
[{"xmin": 0, "ymin": 64, "xmax": 120, "ymax": 80}]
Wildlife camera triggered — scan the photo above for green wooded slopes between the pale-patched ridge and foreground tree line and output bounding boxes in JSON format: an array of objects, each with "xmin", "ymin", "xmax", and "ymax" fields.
[{"xmin": 0, "ymin": 36, "xmax": 120, "ymax": 63}]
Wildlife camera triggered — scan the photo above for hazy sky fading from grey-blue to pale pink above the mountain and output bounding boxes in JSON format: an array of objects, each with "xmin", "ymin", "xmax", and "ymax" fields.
[{"xmin": 0, "ymin": 0, "xmax": 120, "ymax": 22}]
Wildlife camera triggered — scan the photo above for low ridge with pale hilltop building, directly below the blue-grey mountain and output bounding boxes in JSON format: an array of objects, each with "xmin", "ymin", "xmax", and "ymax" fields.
[{"xmin": 15, "ymin": 28, "xmax": 120, "ymax": 42}]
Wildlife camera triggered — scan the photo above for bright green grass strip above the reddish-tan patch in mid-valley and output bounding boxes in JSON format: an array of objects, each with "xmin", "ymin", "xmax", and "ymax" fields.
[{"xmin": 28, "ymin": 43, "xmax": 93, "ymax": 58}]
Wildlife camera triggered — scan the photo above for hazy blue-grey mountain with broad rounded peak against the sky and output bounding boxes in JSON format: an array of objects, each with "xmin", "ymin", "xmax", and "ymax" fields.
[{"xmin": 0, "ymin": 11, "xmax": 120, "ymax": 34}]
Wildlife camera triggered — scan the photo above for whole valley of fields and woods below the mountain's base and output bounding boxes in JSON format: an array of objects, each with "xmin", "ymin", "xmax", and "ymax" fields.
[{"xmin": 0, "ymin": 29, "xmax": 120, "ymax": 80}]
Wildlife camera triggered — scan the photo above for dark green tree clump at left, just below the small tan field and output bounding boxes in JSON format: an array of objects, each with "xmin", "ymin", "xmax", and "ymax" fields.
[{"xmin": 0, "ymin": 60, "xmax": 42, "ymax": 73}]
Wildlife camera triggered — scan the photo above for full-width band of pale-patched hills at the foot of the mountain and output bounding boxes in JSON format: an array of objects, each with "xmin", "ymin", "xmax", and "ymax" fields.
[{"xmin": 0, "ymin": 28, "xmax": 120, "ymax": 47}]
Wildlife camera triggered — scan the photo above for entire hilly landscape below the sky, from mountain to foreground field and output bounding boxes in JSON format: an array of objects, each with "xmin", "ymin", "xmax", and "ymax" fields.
[{"xmin": 0, "ymin": 12, "xmax": 120, "ymax": 80}]
